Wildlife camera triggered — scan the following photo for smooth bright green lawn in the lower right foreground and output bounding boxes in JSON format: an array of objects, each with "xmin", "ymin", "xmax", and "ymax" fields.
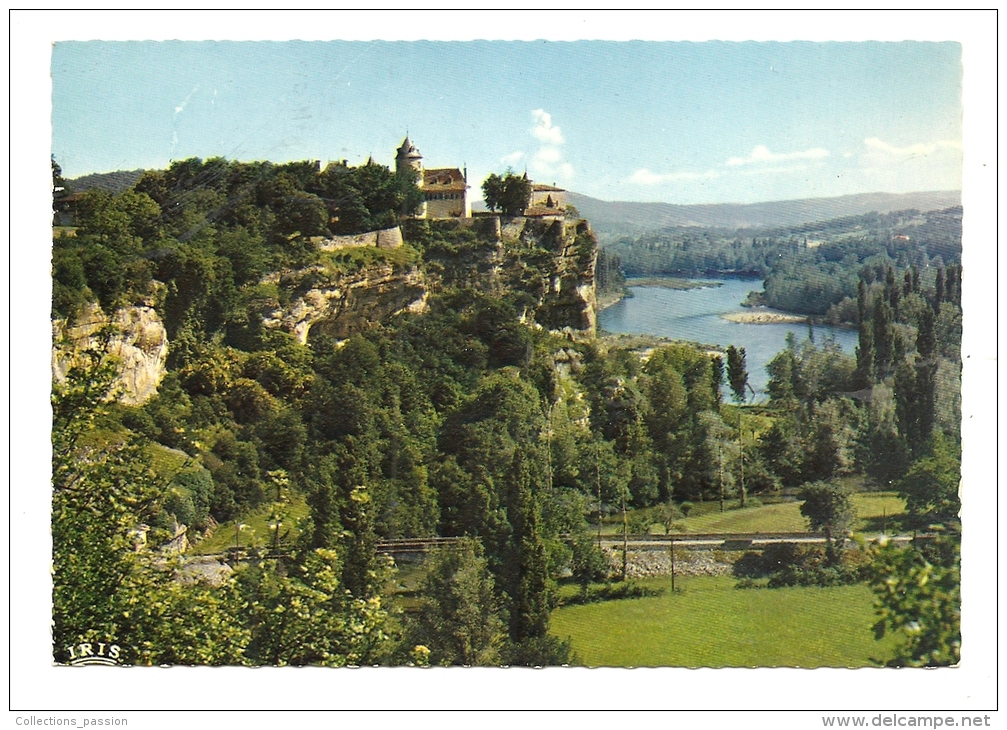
[{"xmin": 551, "ymin": 577, "xmax": 892, "ymax": 667}]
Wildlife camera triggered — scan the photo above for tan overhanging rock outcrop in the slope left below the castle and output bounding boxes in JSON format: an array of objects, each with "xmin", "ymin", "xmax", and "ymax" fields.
[{"xmin": 263, "ymin": 264, "xmax": 427, "ymax": 344}]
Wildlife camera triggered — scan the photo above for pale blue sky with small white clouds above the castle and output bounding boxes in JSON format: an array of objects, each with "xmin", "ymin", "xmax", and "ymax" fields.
[{"xmin": 51, "ymin": 41, "xmax": 962, "ymax": 203}]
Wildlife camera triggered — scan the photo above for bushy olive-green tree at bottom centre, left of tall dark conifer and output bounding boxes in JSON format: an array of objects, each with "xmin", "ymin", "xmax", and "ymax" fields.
[{"xmin": 407, "ymin": 539, "xmax": 507, "ymax": 667}]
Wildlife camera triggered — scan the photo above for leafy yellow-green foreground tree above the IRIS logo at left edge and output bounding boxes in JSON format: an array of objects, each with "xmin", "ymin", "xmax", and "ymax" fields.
[{"xmin": 51, "ymin": 348, "xmax": 249, "ymax": 665}]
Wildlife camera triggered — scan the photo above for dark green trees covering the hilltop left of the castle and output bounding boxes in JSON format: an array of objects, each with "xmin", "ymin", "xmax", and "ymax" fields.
[{"xmin": 52, "ymin": 158, "xmax": 422, "ymax": 326}]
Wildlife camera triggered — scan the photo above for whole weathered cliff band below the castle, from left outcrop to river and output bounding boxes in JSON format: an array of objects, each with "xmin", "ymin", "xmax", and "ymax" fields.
[{"xmin": 263, "ymin": 216, "xmax": 597, "ymax": 343}]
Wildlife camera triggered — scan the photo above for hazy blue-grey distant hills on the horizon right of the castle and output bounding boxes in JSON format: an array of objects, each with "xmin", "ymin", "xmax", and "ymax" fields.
[{"xmin": 567, "ymin": 190, "xmax": 962, "ymax": 242}]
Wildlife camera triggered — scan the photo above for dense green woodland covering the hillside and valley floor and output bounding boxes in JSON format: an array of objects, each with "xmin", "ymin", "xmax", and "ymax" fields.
[{"xmin": 52, "ymin": 154, "xmax": 962, "ymax": 666}]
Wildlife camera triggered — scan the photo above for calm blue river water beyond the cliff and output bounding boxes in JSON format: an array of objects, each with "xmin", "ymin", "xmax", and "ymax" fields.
[{"xmin": 598, "ymin": 279, "xmax": 857, "ymax": 400}]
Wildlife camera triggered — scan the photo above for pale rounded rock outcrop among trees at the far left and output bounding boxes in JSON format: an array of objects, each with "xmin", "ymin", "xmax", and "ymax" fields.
[{"xmin": 52, "ymin": 304, "xmax": 168, "ymax": 406}]
